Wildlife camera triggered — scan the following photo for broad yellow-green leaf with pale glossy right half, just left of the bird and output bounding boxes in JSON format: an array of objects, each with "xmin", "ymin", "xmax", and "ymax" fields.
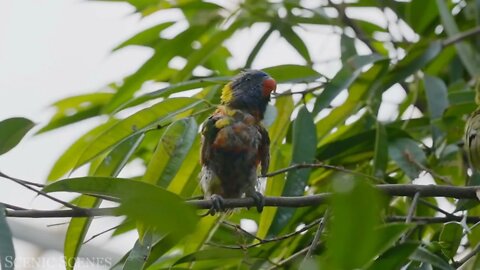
[{"xmin": 143, "ymin": 117, "xmax": 198, "ymax": 188}]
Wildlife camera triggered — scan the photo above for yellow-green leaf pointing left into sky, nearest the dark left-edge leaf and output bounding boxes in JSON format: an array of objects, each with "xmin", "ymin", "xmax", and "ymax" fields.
[{"xmin": 37, "ymin": 93, "xmax": 113, "ymax": 134}]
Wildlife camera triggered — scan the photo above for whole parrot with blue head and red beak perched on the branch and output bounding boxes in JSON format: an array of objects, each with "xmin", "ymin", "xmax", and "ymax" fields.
[{"xmin": 200, "ymin": 70, "xmax": 277, "ymax": 215}]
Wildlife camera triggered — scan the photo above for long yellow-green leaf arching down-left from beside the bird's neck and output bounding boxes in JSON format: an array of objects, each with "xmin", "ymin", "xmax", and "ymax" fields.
[{"xmin": 75, "ymin": 98, "xmax": 207, "ymax": 168}]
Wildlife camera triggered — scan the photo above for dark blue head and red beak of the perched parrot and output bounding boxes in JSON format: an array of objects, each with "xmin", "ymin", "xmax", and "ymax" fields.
[{"xmin": 221, "ymin": 70, "xmax": 277, "ymax": 120}]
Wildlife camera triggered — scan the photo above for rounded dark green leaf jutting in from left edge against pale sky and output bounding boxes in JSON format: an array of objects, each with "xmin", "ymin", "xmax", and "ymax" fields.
[{"xmin": 0, "ymin": 117, "xmax": 35, "ymax": 155}]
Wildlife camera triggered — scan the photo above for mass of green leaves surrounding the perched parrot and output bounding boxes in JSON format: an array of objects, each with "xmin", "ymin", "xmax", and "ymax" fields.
[{"xmin": 0, "ymin": 0, "xmax": 480, "ymax": 269}]
